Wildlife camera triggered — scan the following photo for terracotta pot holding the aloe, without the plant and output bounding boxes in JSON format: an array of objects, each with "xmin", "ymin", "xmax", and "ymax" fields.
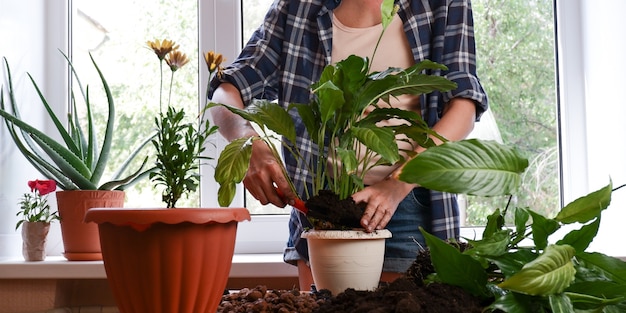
[{"xmin": 56, "ymin": 190, "xmax": 124, "ymax": 261}]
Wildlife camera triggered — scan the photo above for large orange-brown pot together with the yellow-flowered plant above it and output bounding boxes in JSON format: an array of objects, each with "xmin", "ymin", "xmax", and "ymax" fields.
[{"xmin": 85, "ymin": 40, "xmax": 250, "ymax": 313}]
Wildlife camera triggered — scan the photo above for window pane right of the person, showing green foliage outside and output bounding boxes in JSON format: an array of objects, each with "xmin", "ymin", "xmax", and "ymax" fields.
[{"xmin": 464, "ymin": 0, "xmax": 560, "ymax": 226}]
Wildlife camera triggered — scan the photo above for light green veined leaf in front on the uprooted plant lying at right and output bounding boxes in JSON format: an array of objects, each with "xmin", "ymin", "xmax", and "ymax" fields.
[{"xmin": 498, "ymin": 245, "xmax": 576, "ymax": 296}]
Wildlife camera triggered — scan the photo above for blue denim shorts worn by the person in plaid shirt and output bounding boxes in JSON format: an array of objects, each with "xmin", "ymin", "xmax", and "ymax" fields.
[{"xmin": 283, "ymin": 187, "xmax": 431, "ymax": 273}]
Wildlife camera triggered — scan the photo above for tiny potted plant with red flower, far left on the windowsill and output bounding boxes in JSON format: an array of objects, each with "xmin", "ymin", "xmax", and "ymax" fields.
[{"xmin": 15, "ymin": 179, "xmax": 59, "ymax": 261}]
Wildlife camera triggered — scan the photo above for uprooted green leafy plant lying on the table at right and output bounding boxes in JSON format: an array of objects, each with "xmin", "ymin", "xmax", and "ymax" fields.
[{"xmin": 405, "ymin": 170, "xmax": 626, "ymax": 312}]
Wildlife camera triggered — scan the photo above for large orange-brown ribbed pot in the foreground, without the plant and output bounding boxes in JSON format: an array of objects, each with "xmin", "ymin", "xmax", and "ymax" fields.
[{"xmin": 85, "ymin": 208, "xmax": 250, "ymax": 313}]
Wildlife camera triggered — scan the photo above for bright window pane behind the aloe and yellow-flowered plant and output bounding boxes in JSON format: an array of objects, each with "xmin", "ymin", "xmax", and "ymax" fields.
[{"xmin": 72, "ymin": 0, "xmax": 199, "ymax": 207}]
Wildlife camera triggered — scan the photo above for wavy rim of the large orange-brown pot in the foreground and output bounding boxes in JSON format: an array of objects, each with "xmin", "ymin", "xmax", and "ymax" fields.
[{"xmin": 85, "ymin": 208, "xmax": 250, "ymax": 225}]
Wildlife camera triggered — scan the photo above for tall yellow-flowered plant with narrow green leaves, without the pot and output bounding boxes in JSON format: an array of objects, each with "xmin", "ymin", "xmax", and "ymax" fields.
[{"xmin": 148, "ymin": 39, "xmax": 222, "ymax": 208}]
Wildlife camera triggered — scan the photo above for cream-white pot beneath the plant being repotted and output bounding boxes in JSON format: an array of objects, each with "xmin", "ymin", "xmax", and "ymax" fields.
[{"xmin": 302, "ymin": 229, "xmax": 391, "ymax": 295}]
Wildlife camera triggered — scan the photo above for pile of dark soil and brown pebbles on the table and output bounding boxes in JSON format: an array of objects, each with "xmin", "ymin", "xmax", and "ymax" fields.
[{"xmin": 218, "ymin": 247, "xmax": 485, "ymax": 313}]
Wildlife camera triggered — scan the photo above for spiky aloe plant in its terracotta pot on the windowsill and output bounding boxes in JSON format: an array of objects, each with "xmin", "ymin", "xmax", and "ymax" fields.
[{"xmin": 0, "ymin": 54, "xmax": 151, "ymax": 260}]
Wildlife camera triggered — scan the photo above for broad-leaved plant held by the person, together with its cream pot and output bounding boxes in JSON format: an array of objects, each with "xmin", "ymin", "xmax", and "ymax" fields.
[{"xmin": 209, "ymin": 1, "xmax": 525, "ymax": 293}]
